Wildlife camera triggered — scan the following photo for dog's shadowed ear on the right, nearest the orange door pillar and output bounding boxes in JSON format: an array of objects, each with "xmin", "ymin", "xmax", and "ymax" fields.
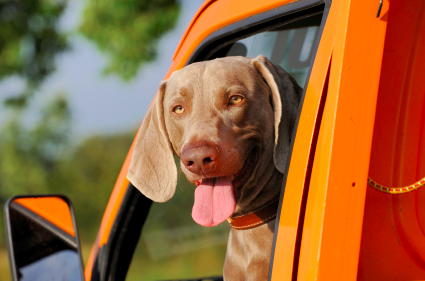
[{"xmin": 251, "ymin": 55, "xmax": 303, "ymax": 173}]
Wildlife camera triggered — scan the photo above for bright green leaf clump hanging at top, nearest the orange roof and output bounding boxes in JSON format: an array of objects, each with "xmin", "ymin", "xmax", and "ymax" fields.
[{"xmin": 80, "ymin": 0, "xmax": 179, "ymax": 80}]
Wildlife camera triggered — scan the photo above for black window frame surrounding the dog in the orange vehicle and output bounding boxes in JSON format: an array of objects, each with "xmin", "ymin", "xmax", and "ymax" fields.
[{"xmin": 96, "ymin": 0, "xmax": 331, "ymax": 281}]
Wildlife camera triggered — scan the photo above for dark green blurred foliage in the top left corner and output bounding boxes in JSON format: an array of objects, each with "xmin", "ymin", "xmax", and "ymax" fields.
[{"xmin": 0, "ymin": 0, "xmax": 68, "ymax": 108}]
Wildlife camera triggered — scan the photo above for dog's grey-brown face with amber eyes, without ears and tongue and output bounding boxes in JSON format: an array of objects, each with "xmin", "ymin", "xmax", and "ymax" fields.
[{"xmin": 164, "ymin": 59, "xmax": 274, "ymax": 186}]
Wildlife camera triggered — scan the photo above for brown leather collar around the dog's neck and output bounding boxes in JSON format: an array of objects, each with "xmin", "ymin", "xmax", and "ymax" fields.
[{"xmin": 227, "ymin": 197, "xmax": 279, "ymax": 229}]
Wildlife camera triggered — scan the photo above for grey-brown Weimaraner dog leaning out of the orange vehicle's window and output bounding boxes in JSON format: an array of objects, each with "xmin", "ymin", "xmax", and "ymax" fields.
[{"xmin": 127, "ymin": 55, "xmax": 302, "ymax": 281}]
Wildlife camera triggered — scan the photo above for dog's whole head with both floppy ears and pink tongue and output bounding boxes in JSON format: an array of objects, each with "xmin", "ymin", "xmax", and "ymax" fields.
[{"xmin": 127, "ymin": 55, "xmax": 302, "ymax": 226}]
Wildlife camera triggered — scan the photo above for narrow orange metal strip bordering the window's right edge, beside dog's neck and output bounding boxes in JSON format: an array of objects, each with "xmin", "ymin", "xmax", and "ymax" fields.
[{"xmin": 271, "ymin": 3, "xmax": 332, "ymax": 281}]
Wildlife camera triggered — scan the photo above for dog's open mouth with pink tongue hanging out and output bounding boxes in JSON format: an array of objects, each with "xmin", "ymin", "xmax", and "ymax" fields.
[{"xmin": 192, "ymin": 148, "xmax": 258, "ymax": 226}]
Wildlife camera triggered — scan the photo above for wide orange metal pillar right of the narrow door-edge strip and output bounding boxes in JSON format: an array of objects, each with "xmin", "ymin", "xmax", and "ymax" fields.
[{"xmin": 297, "ymin": 1, "xmax": 389, "ymax": 280}]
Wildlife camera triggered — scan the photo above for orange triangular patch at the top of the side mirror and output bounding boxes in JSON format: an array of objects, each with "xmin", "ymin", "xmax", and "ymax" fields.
[{"xmin": 13, "ymin": 197, "xmax": 75, "ymax": 237}]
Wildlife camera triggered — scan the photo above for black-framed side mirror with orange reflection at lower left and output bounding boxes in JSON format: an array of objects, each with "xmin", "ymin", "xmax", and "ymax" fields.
[{"xmin": 4, "ymin": 195, "xmax": 84, "ymax": 281}]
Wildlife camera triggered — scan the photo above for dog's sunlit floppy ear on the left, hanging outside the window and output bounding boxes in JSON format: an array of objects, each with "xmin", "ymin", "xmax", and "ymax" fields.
[{"xmin": 127, "ymin": 81, "xmax": 177, "ymax": 202}]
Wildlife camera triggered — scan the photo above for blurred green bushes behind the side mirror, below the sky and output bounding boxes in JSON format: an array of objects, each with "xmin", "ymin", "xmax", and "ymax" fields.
[{"xmin": 0, "ymin": 95, "xmax": 135, "ymax": 244}]
